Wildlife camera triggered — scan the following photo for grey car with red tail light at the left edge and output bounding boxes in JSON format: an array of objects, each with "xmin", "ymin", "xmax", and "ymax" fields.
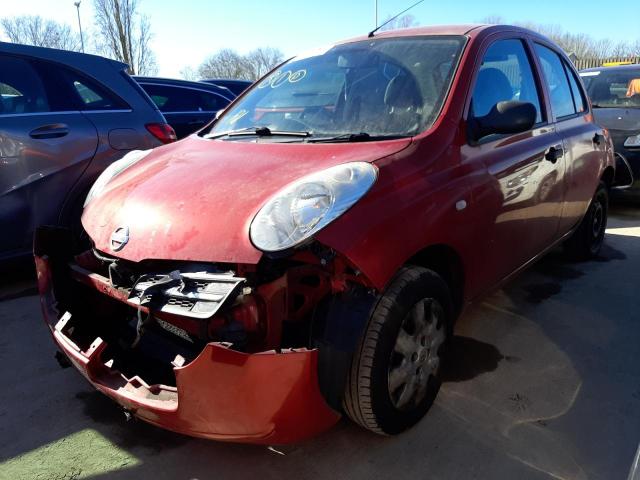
[{"xmin": 0, "ymin": 42, "xmax": 175, "ymax": 264}]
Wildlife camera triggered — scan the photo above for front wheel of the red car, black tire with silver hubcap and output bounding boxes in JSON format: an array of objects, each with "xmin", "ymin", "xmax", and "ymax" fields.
[{"xmin": 343, "ymin": 266, "xmax": 453, "ymax": 435}]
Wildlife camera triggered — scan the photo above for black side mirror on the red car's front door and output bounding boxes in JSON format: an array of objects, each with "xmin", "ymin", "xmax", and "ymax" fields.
[{"xmin": 471, "ymin": 100, "xmax": 538, "ymax": 140}]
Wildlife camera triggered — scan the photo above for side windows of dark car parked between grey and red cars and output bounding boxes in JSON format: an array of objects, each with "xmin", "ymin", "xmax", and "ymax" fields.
[{"xmin": 141, "ymin": 83, "xmax": 229, "ymax": 113}]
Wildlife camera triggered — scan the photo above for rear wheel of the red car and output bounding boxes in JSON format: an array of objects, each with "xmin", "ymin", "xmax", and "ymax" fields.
[{"xmin": 564, "ymin": 182, "xmax": 609, "ymax": 260}]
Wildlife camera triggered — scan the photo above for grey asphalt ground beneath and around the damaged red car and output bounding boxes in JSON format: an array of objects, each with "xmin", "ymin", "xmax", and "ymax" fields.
[{"xmin": 0, "ymin": 206, "xmax": 640, "ymax": 480}]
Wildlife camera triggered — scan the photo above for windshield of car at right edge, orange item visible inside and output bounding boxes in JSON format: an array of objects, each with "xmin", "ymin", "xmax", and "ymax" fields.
[{"xmin": 580, "ymin": 67, "xmax": 640, "ymax": 108}]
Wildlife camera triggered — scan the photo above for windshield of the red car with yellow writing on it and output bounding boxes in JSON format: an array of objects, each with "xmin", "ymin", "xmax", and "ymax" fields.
[{"xmin": 204, "ymin": 36, "xmax": 465, "ymax": 138}]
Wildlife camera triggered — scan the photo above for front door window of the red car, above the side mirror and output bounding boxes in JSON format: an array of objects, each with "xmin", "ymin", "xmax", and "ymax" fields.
[{"xmin": 472, "ymin": 39, "xmax": 542, "ymax": 123}]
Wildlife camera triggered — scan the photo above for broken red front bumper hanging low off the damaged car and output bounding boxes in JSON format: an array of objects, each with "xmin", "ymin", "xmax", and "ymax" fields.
[{"xmin": 35, "ymin": 233, "xmax": 339, "ymax": 444}]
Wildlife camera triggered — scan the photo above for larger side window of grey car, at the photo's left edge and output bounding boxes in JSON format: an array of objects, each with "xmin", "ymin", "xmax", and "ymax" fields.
[{"xmin": 0, "ymin": 56, "xmax": 49, "ymax": 115}]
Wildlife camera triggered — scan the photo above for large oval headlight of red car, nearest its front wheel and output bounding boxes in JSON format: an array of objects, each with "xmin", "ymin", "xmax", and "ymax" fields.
[{"xmin": 249, "ymin": 162, "xmax": 377, "ymax": 252}]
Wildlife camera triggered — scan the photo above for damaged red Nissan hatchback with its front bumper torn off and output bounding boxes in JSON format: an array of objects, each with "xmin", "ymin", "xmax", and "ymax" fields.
[{"xmin": 34, "ymin": 26, "xmax": 615, "ymax": 444}]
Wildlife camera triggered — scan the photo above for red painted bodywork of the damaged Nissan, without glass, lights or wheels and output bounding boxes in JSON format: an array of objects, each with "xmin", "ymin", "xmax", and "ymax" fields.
[{"xmin": 37, "ymin": 26, "xmax": 614, "ymax": 443}]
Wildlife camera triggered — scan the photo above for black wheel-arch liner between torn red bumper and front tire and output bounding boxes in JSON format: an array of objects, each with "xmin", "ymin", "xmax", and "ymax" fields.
[{"xmin": 313, "ymin": 287, "xmax": 378, "ymax": 411}]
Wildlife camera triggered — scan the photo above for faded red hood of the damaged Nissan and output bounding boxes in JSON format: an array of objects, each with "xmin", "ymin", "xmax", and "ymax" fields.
[{"xmin": 82, "ymin": 135, "xmax": 411, "ymax": 264}]
